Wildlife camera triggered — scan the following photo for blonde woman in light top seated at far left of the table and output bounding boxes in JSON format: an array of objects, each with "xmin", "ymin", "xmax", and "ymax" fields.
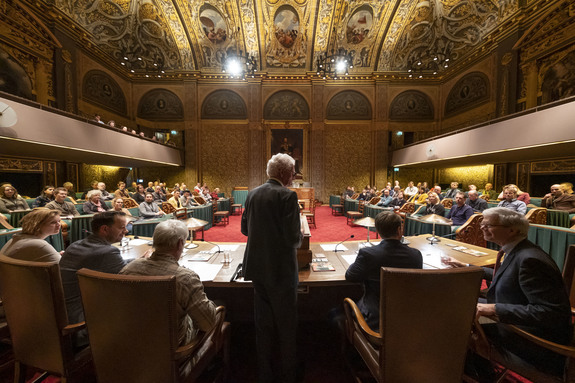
[{"xmin": 0, "ymin": 209, "xmax": 60, "ymax": 262}]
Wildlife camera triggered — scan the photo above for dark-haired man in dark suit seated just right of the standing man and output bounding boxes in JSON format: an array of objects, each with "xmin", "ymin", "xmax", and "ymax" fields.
[{"xmin": 345, "ymin": 211, "xmax": 423, "ymax": 331}]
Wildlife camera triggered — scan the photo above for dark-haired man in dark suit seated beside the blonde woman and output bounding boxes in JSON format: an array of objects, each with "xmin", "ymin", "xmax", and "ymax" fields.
[{"xmin": 60, "ymin": 211, "xmax": 138, "ymax": 346}]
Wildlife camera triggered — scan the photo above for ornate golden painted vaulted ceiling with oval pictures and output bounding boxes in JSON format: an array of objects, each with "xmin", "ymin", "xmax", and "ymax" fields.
[{"xmin": 44, "ymin": 0, "xmax": 518, "ymax": 75}]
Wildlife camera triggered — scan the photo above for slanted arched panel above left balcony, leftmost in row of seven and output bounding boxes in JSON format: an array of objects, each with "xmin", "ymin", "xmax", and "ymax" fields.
[{"xmin": 82, "ymin": 70, "xmax": 128, "ymax": 116}]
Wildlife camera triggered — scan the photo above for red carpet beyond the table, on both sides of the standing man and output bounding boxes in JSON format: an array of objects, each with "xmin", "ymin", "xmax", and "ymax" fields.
[{"xmin": 205, "ymin": 205, "xmax": 379, "ymax": 242}]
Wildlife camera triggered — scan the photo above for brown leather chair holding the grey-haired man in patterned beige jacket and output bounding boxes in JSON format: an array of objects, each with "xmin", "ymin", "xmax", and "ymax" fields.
[{"xmin": 78, "ymin": 269, "xmax": 229, "ymax": 383}]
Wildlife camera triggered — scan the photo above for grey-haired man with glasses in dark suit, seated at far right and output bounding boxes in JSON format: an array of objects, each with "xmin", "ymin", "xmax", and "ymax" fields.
[{"xmin": 448, "ymin": 208, "xmax": 572, "ymax": 381}]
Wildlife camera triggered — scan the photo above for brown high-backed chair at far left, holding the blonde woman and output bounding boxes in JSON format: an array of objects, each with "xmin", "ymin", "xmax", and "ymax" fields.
[{"xmin": 0, "ymin": 255, "xmax": 92, "ymax": 383}]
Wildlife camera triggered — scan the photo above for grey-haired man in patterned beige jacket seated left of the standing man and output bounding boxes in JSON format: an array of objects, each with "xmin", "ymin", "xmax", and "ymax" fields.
[{"xmin": 120, "ymin": 220, "xmax": 216, "ymax": 376}]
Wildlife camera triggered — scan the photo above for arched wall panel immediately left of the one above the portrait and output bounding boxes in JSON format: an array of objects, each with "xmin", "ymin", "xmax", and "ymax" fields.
[{"xmin": 138, "ymin": 89, "xmax": 184, "ymax": 121}]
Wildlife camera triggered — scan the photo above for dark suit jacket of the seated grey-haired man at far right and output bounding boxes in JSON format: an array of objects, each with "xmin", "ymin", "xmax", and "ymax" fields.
[{"xmin": 484, "ymin": 239, "xmax": 571, "ymax": 344}]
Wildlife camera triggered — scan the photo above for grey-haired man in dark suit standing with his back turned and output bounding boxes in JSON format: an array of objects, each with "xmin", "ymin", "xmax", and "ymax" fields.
[{"xmin": 242, "ymin": 153, "xmax": 302, "ymax": 382}]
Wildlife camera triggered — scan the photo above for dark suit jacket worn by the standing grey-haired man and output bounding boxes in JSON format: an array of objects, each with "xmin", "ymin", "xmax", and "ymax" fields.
[{"xmin": 242, "ymin": 179, "xmax": 303, "ymax": 287}]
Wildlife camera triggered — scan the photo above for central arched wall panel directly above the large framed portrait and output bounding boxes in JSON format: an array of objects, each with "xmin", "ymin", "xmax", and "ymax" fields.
[{"xmin": 264, "ymin": 90, "xmax": 309, "ymax": 120}]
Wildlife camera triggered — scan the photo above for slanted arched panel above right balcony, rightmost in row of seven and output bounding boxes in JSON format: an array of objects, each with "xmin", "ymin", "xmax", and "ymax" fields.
[{"xmin": 445, "ymin": 72, "xmax": 490, "ymax": 116}]
